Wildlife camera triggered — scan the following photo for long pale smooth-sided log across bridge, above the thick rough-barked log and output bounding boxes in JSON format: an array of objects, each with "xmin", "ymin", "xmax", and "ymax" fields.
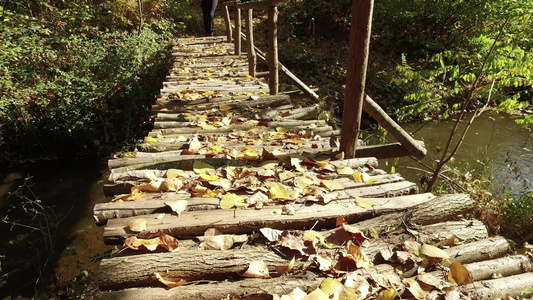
[{"xmin": 104, "ymin": 192, "xmax": 424, "ymax": 244}]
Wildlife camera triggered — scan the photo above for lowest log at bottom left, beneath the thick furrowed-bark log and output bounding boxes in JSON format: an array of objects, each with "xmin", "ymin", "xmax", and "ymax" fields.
[{"xmin": 96, "ymin": 272, "xmax": 324, "ymax": 300}]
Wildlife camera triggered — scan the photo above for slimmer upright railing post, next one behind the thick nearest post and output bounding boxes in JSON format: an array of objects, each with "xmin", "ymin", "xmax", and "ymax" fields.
[{"xmin": 268, "ymin": 6, "xmax": 279, "ymax": 95}]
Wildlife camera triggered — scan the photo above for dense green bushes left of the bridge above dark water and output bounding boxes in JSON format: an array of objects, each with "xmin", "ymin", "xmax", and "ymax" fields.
[{"xmin": 0, "ymin": 1, "xmax": 174, "ymax": 159}]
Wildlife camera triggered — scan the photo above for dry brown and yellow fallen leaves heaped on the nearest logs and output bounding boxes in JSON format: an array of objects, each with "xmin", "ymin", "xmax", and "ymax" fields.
[{"xmin": 120, "ymin": 216, "xmax": 471, "ymax": 300}]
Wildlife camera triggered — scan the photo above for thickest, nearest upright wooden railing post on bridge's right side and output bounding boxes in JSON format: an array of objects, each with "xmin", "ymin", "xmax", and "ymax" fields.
[{"xmin": 340, "ymin": 0, "xmax": 374, "ymax": 158}]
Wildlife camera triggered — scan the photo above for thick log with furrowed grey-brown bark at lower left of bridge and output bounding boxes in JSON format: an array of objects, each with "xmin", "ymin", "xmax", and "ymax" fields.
[{"xmin": 98, "ymin": 247, "xmax": 290, "ymax": 289}]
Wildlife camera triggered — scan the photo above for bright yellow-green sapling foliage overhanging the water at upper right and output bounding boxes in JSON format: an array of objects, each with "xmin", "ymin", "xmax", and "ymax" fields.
[{"xmin": 386, "ymin": 1, "xmax": 533, "ymax": 120}]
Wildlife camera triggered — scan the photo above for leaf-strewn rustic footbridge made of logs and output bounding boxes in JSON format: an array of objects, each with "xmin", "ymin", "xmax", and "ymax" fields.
[{"xmin": 94, "ymin": 0, "xmax": 533, "ymax": 300}]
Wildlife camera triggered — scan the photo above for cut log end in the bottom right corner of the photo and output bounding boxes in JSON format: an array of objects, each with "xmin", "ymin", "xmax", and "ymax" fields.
[{"xmin": 458, "ymin": 272, "xmax": 533, "ymax": 300}]
